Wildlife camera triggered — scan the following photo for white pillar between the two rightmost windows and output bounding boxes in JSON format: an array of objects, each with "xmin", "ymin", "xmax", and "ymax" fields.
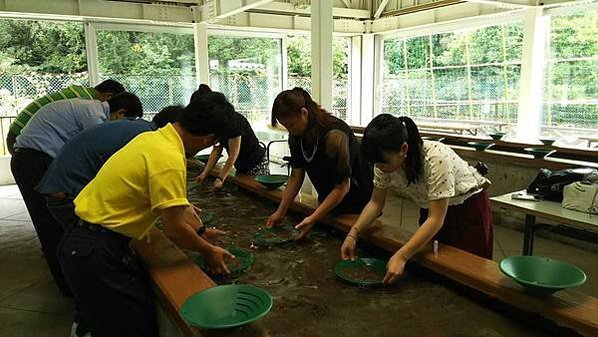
[{"xmin": 517, "ymin": 8, "xmax": 550, "ymax": 142}]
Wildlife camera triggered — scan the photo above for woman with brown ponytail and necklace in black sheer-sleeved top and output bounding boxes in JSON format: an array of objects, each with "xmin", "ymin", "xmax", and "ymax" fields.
[{"xmin": 266, "ymin": 88, "xmax": 373, "ymax": 239}]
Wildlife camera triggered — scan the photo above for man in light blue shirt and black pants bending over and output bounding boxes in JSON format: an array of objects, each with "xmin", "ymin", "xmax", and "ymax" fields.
[{"xmin": 10, "ymin": 92, "xmax": 142, "ymax": 296}]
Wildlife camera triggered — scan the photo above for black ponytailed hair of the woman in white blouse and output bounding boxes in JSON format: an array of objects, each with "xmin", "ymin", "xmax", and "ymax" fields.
[{"xmin": 361, "ymin": 114, "xmax": 424, "ymax": 184}]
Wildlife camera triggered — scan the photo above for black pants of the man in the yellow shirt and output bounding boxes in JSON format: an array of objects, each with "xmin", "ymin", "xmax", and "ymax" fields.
[{"xmin": 58, "ymin": 222, "xmax": 158, "ymax": 337}]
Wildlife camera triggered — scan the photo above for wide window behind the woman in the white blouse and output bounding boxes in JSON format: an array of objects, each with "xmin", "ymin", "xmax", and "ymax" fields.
[{"xmin": 379, "ymin": 23, "xmax": 523, "ymax": 133}]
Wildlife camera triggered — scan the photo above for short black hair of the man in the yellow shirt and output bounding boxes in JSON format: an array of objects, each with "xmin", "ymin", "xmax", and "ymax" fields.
[{"xmin": 177, "ymin": 92, "xmax": 235, "ymax": 136}]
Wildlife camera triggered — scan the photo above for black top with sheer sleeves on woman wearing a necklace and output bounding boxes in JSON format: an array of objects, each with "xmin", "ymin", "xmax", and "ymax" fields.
[{"xmin": 289, "ymin": 117, "xmax": 374, "ymax": 214}]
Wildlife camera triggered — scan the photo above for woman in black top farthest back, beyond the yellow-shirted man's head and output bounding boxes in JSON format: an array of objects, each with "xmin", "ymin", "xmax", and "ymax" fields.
[{"xmin": 192, "ymin": 84, "xmax": 270, "ymax": 191}]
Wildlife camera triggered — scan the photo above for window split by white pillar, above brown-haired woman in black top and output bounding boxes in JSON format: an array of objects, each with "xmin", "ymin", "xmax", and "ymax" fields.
[{"xmin": 285, "ymin": 35, "xmax": 351, "ymax": 120}]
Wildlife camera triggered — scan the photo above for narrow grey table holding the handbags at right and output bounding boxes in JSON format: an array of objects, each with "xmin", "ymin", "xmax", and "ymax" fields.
[{"xmin": 490, "ymin": 191, "xmax": 598, "ymax": 255}]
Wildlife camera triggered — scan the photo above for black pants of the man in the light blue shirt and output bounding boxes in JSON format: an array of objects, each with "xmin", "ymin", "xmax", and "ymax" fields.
[{"xmin": 10, "ymin": 149, "xmax": 72, "ymax": 296}]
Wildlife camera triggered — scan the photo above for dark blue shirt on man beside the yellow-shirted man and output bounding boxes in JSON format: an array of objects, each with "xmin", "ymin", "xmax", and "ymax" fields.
[{"xmin": 37, "ymin": 120, "xmax": 155, "ymax": 198}]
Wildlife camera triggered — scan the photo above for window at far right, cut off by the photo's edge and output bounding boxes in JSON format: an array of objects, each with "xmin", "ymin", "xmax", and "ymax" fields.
[{"xmin": 541, "ymin": 11, "xmax": 598, "ymax": 145}]
